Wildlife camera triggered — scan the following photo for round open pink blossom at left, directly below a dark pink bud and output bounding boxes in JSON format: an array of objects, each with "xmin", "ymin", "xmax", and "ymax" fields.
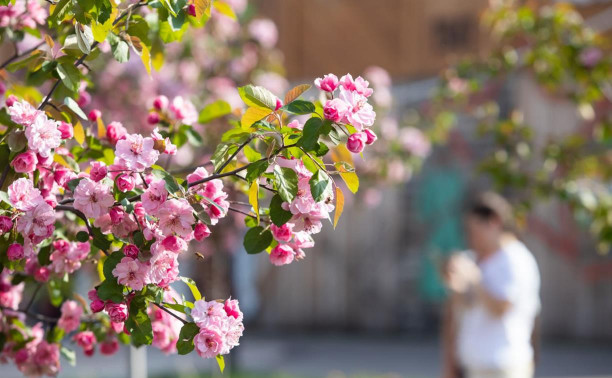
[{"xmin": 74, "ymin": 178, "xmax": 115, "ymax": 218}]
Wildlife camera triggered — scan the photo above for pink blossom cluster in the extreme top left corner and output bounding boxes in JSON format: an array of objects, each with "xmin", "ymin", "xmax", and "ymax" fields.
[{"xmin": 0, "ymin": 0, "xmax": 47, "ymax": 30}]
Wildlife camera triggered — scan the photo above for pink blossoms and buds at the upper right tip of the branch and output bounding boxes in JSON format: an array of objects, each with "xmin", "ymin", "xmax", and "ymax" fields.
[{"xmin": 315, "ymin": 74, "xmax": 377, "ymax": 153}]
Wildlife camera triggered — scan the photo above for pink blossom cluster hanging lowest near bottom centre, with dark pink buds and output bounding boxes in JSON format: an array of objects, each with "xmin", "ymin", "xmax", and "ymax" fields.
[{"xmin": 191, "ymin": 298, "xmax": 244, "ymax": 358}]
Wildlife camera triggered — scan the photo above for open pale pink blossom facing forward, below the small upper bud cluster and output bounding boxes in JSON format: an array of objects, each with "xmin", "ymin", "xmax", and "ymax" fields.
[{"xmin": 115, "ymin": 134, "xmax": 159, "ymax": 171}]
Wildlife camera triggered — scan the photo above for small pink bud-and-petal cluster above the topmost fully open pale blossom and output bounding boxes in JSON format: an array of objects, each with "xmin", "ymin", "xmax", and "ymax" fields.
[{"xmin": 147, "ymin": 95, "xmax": 198, "ymax": 125}]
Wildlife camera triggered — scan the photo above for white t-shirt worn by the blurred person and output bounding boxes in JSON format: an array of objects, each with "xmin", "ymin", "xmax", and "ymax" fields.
[{"xmin": 457, "ymin": 240, "xmax": 540, "ymax": 369}]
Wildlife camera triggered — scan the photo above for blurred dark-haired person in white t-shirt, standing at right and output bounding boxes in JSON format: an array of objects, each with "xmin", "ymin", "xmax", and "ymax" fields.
[{"xmin": 443, "ymin": 192, "xmax": 540, "ymax": 378}]
